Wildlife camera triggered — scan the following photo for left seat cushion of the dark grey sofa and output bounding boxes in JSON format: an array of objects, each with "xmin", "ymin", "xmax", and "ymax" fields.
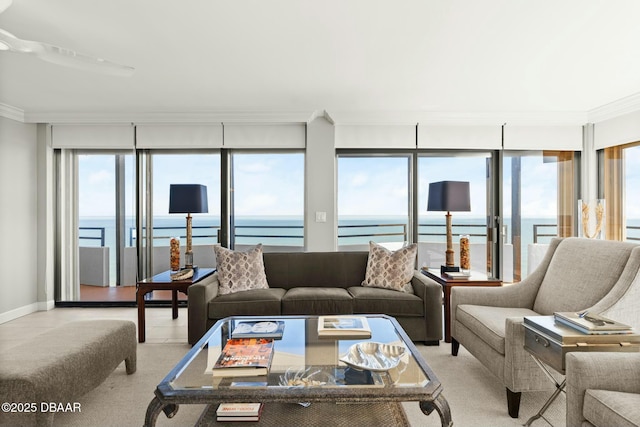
[{"xmin": 208, "ymin": 288, "xmax": 286, "ymax": 319}]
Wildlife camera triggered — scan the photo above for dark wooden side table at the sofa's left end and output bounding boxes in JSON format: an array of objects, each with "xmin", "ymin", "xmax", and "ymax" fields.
[{"xmin": 136, "ymin": 268, "xmax": 216, "ymax": 342}]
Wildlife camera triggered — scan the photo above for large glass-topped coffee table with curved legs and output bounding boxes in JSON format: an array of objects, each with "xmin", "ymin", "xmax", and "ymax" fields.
[{"xmin": 145, "ymin": 315, "xmax": 453, "ymax": 427}]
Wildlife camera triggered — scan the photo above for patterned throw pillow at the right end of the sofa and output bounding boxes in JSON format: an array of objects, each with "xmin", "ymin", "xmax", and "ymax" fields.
[{"xmin": 362, "ymin": 242, "xmax": 418, "ymax": 293}]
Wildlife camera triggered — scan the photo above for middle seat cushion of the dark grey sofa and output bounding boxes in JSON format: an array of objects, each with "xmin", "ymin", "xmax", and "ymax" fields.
[{"xmin": 282, "ymin": 287, "xmax": 353, "ymax": 315}]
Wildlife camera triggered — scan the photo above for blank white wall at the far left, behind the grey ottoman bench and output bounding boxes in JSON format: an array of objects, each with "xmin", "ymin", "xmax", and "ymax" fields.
[{"xmin": 0, "ymin": 117, "xmax": 39, "ymax": 323}]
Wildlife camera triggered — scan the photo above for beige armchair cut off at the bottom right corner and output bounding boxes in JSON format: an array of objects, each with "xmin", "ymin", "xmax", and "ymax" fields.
[{"xmin": 565, "ymin": 266, "xmax": 640, "ymax": 427}]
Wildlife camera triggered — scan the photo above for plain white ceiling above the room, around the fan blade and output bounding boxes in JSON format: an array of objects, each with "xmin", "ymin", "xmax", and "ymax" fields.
[{"xmin": 0, "ymin": 0, "xmax": 640, "ymax": 121}]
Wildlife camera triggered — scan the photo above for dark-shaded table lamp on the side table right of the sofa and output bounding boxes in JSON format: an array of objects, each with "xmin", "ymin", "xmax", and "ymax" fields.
[{"xmin": 427, "ymin": 181, "xmax": 471, "ymax": 273}]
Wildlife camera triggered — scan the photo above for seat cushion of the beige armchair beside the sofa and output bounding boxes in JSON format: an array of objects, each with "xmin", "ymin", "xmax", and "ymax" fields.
[{"xmin": 456, "ymin": 304, "xmax": 538, "ymax": 354}]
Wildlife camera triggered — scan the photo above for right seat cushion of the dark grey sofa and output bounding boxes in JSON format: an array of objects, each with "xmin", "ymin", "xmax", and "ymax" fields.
[{"xmin": 347, "ymin": 286, "xmax": 424, "ymax": 317}]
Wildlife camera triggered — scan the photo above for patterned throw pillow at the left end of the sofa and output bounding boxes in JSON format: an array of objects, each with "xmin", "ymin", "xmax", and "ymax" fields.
[{"xmin": 213, "ymin": 244, "xmax": 269, "ymax": 295}]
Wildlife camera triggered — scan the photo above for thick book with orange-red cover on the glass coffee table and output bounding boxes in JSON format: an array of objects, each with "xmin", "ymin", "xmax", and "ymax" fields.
[{"xmin": 211, "ymin": 338, "xmax": 273, "ymax": 377}]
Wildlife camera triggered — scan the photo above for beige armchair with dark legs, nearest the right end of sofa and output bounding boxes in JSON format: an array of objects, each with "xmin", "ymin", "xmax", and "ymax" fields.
[{"xmin": 451, "ymin": 238, "xmax": 640, "ymax": 418}]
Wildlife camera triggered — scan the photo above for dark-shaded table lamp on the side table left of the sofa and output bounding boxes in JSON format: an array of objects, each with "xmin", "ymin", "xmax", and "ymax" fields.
[{"xmin": 169, "ymin": 184, "xmax": 209, "ymax": 268}]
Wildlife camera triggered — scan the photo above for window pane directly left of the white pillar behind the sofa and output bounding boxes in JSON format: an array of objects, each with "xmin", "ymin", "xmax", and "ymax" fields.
[{"xmin": 230, "ymin": 152, "xmax": 304, "ymax": 251}]
